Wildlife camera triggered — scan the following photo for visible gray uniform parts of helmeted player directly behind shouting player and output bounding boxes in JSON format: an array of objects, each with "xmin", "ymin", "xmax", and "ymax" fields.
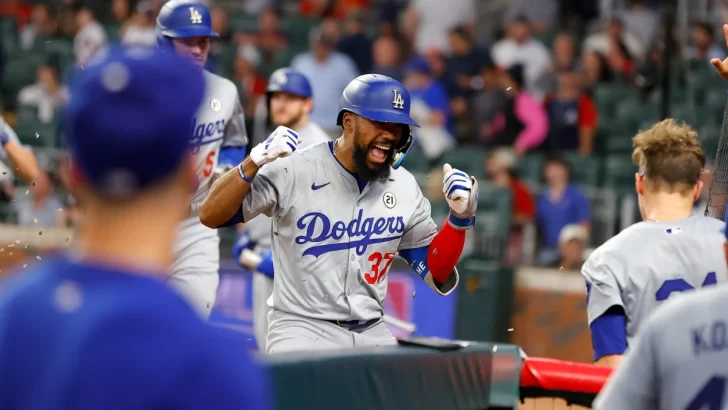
[{"xmin": 245, "ymin": 121, "xmax": 331, "ymax": 351}]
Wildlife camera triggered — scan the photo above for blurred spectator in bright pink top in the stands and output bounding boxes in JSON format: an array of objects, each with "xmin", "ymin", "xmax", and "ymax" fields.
[{"xmin": 480, "ymin": 64, "xmax": 548, "ymax": 156}]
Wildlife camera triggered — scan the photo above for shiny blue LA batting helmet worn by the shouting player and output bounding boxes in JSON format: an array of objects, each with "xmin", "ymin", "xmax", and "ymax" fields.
[{"xmin": 336, "ymin": 74, "xmax": 419, "ymax": 169}]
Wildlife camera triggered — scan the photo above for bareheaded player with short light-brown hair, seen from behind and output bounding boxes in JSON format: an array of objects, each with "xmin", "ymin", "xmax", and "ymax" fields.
[{"xmin": 581, "ymin": 119, "xmax": 728, "ymax": 366}]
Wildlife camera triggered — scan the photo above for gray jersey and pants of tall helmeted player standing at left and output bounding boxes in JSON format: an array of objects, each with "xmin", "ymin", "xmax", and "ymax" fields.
[{"xmin": 169, "ymin": 71, "xmax": 248, "ymax": 318}]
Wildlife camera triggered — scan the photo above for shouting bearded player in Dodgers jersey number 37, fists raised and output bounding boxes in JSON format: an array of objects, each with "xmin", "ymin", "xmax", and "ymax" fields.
[{"xmin": 200, "ymin": 74, "xmax": 478, "ymax": 353}]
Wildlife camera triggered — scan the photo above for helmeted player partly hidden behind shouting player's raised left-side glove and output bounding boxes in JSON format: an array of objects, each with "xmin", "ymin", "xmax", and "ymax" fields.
[{"xmin": 233, "ymin": 68, "xmax": 331, "ymax": 351}]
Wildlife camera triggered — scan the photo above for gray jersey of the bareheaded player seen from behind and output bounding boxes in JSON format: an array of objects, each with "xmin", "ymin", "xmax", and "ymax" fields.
[{"xmin": 581, "ymin": 216, "xmax": 728, "ymax": 344}]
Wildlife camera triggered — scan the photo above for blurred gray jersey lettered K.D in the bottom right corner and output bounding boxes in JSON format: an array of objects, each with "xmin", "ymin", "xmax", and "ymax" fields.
[{"xmin": 593, "ymin": 286, "xmax": 728, "ymax": 410}]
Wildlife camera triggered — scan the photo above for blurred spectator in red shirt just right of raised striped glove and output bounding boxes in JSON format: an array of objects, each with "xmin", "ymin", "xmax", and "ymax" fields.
[{"xmin": 485, "ymin": 148, "xmax": 536, "ymax": 225}]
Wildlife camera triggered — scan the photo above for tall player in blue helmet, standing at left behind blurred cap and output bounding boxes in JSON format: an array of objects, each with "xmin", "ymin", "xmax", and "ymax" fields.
[{"xmin": 156, "ymin": 0, "xmax": 248, "ymax": 318}]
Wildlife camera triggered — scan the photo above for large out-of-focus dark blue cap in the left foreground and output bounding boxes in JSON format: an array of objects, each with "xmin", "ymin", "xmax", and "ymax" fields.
[{"xmin": 66, "ymin": 47, "xmax": 205, "ymax": 197}]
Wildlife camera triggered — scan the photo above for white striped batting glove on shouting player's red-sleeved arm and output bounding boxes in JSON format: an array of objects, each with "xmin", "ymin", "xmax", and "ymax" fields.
[{"xmin": 442, "ymin": 164, "xmax": 478, "ymax": 229}]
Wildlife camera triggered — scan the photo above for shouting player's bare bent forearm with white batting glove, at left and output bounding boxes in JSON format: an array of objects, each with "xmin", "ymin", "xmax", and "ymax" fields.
[{"xmin": 199, "ymin": 127, "xmax": 299, "ymax": 228}]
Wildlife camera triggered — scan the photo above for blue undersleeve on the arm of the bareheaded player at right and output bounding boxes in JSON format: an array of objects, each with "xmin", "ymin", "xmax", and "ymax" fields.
[{"xmin": 590, "ymin": 306, "xmax": 627, "ymax": 361}]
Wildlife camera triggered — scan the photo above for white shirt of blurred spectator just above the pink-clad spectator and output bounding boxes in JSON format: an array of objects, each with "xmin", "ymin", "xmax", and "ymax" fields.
[{"xmin": 491, "ymin": 38, "xmax": 551, "ymax": 100}]
